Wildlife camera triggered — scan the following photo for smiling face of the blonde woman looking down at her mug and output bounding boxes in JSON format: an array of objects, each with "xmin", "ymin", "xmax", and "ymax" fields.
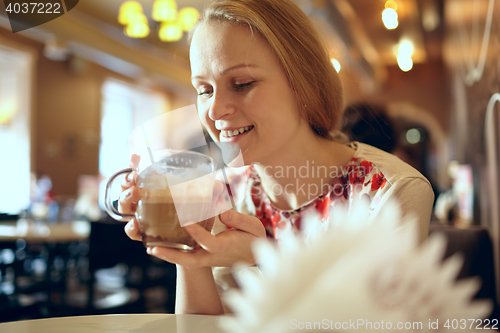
[{"xmin": 190, "ymin": 21, "xmax": 310, "ymax": 165}]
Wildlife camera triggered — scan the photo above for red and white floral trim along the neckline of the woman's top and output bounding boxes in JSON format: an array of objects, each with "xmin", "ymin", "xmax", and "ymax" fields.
[{"xmin": 245, "ymin": 157, "xmax": 387, "ymax": 240}]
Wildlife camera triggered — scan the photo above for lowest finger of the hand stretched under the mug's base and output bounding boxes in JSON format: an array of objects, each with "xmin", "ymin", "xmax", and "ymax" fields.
[{"xmin": 147, "ymin": 246, "xmax": 211, "ymax": 268}]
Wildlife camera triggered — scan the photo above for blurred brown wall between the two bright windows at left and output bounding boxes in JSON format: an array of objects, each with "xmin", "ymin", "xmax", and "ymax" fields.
[{"xmin": 0, "ymin": 27, "xmax": 182, "ymax": 197}]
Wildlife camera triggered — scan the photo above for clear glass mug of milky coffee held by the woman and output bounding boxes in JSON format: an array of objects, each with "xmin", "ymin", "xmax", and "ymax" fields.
[{"xmin": 105, "ymin": 149, "xmax": 215, "ymax": 252}]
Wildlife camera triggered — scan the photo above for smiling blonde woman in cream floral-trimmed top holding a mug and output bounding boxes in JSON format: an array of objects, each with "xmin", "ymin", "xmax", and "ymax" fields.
[{"xmin": 120, "ymin": 0, "xmax": 433, "ymax": 314}]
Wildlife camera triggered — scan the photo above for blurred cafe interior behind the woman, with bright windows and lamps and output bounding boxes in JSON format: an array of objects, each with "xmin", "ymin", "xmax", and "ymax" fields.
[{"xmin": 0, "ymin": 0, "xmax": 500, "ymax": 322}]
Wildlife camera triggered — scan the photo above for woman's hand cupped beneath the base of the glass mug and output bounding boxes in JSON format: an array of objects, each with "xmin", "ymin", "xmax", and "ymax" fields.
[{"xmin": 147, "ymin": 210, "xmax": 266, "ymax": 268}]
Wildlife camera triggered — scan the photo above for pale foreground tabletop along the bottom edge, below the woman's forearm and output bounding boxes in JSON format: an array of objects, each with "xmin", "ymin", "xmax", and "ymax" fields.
[{"xmin": 0, "ymin": 314, "xmax": 224, "ymax": 333}]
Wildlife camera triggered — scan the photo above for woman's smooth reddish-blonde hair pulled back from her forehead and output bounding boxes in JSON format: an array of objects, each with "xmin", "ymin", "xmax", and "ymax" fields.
[{"xmin": 191, "ymin": 0, "xmax": 343, "ymax": 139}]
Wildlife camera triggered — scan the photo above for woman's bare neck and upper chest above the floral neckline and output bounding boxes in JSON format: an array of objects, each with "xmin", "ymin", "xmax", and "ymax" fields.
[{"xmin": 255, "ymin": 129, "xmax": 354, "ymax": 210}]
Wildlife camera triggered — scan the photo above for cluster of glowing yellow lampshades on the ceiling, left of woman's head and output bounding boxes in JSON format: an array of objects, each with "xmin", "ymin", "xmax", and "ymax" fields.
[{"xmin": 118, "ymin": 0, "xmax": 200, "ymax": 42}]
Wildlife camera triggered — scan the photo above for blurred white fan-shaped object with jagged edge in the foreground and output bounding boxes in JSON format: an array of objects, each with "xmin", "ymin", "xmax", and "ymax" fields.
[{"xmin": 221, "ymin": 198, "xmax": 491, "ymax": 333}]
